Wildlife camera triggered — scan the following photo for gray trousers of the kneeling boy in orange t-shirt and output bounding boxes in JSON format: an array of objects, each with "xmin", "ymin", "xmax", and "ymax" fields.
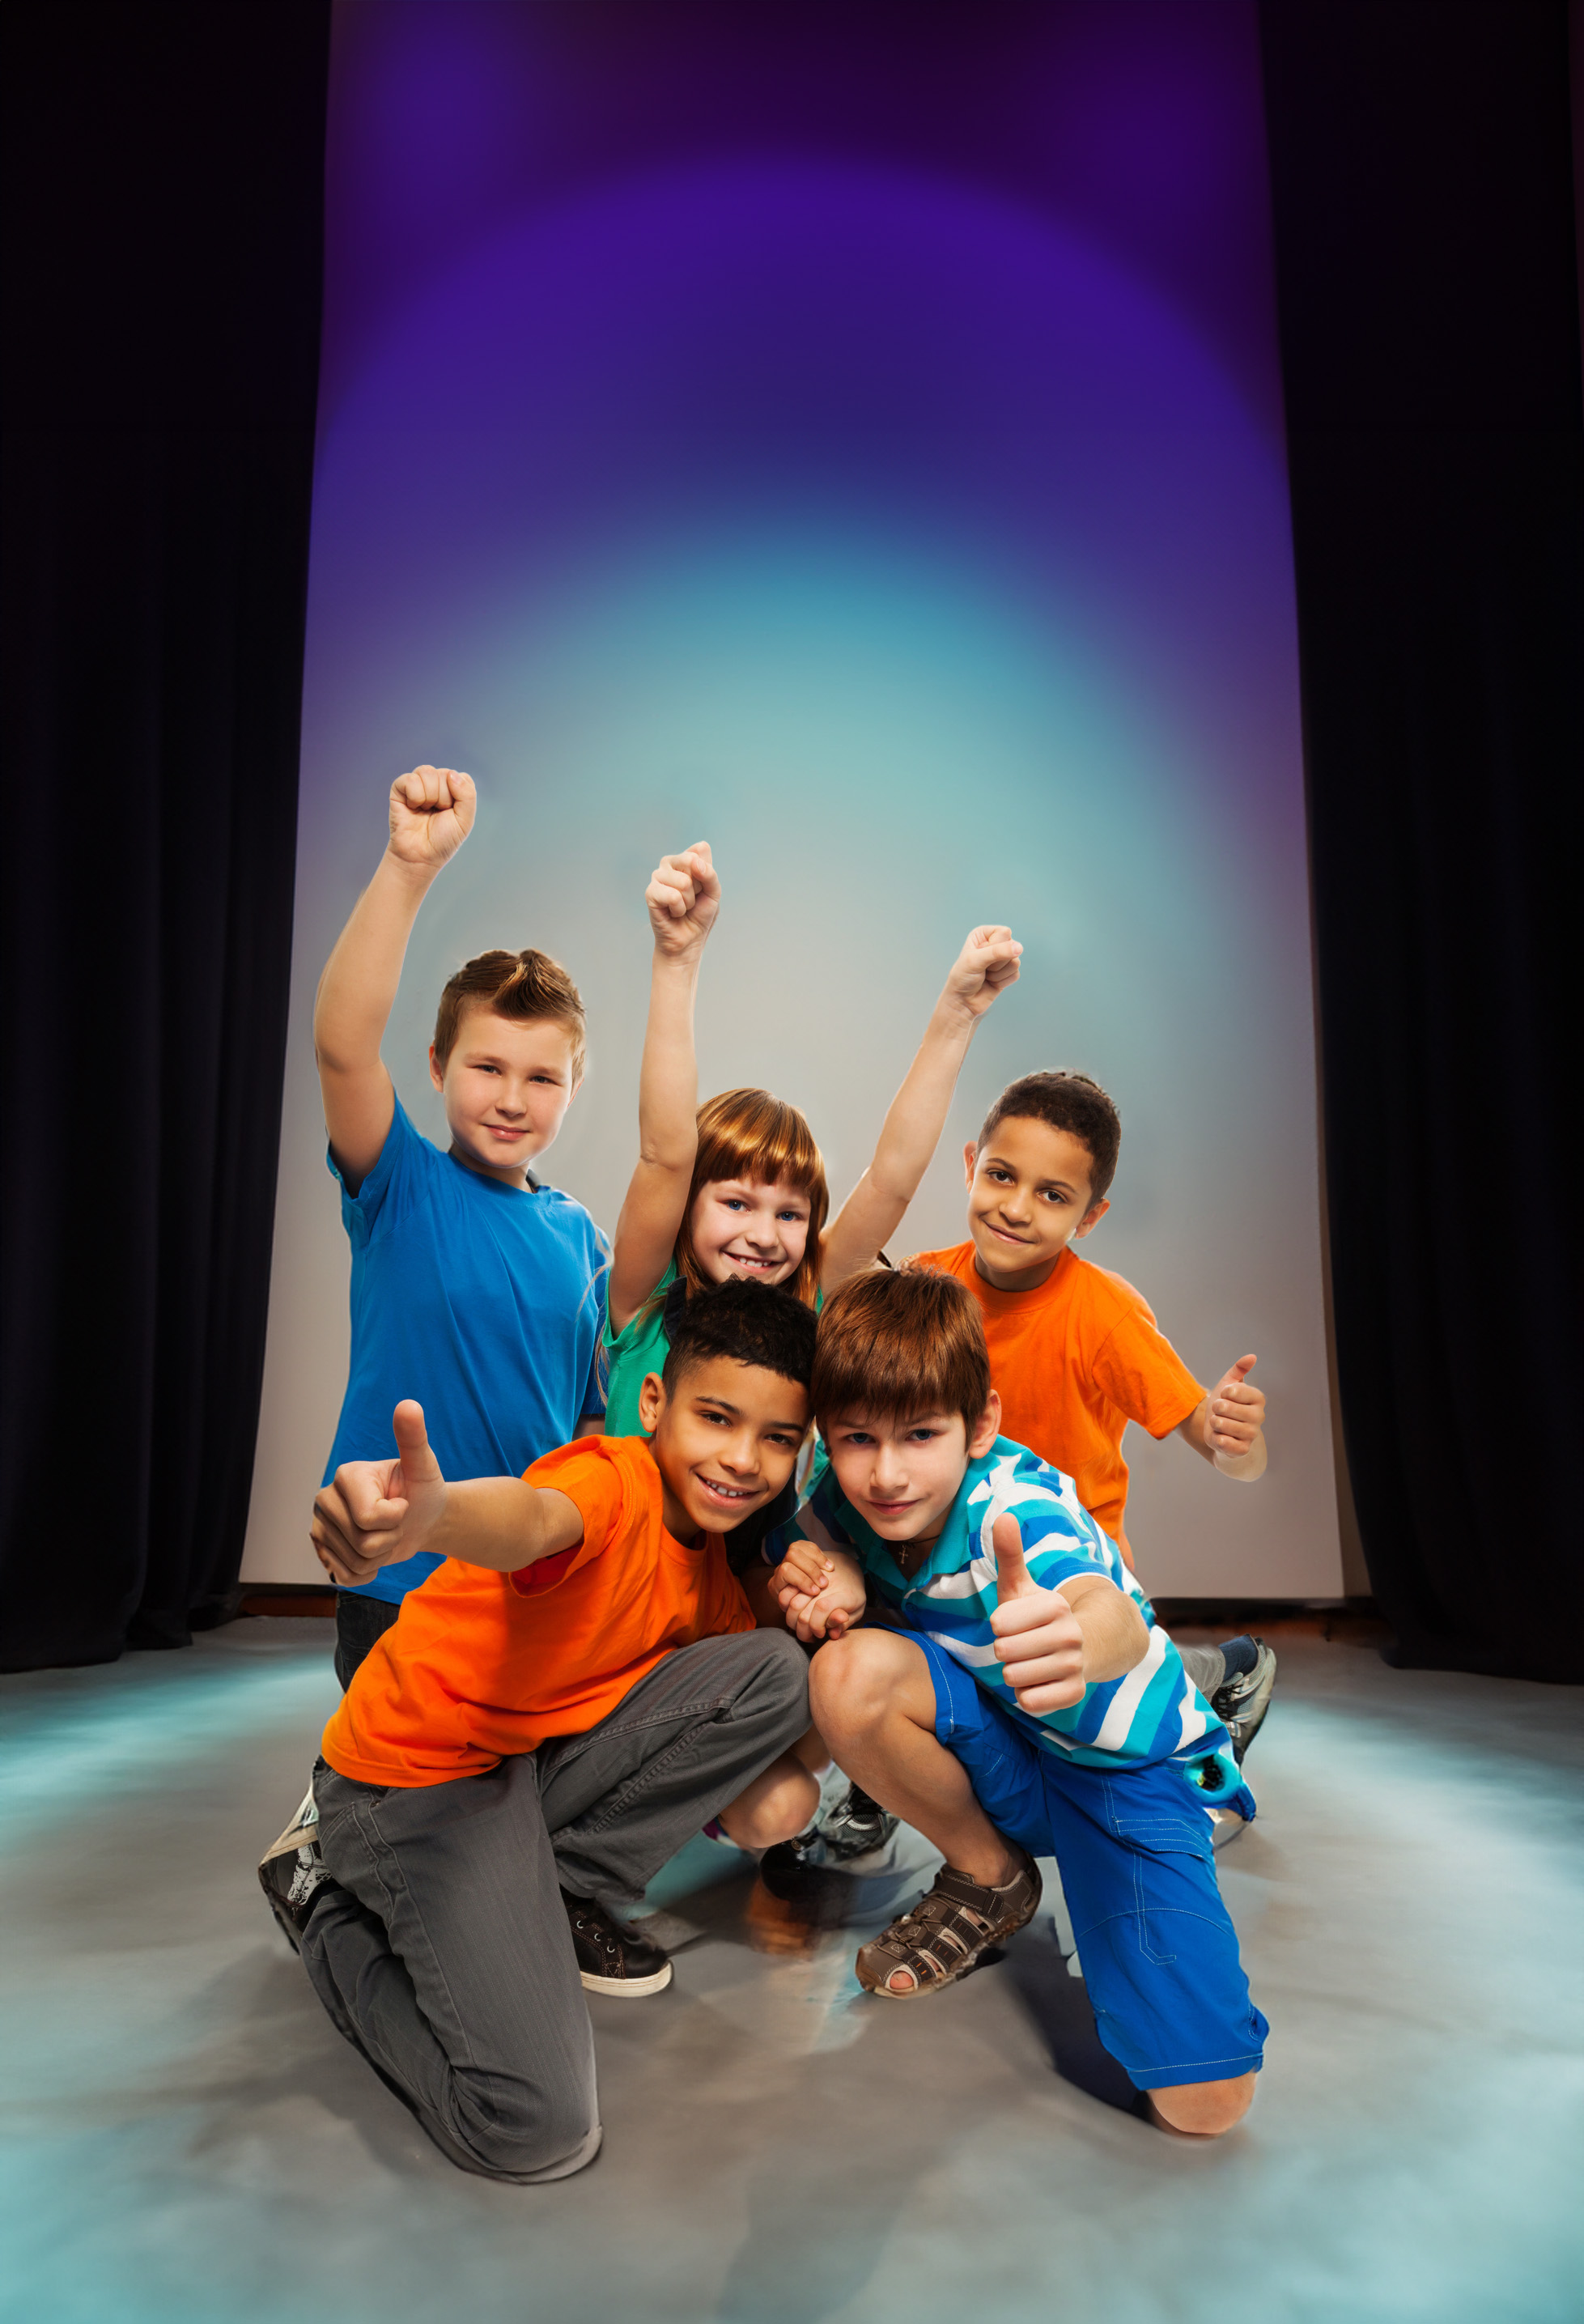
[{"xmin": 302, "ymin": 1629, "xmax": 809, "ymax": 2185}]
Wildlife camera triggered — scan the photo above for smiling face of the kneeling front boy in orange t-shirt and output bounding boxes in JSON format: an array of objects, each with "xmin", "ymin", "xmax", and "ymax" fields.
[{"xmin": 639, "ymin": 1355, "xmax": 809, "ymax": 1540}]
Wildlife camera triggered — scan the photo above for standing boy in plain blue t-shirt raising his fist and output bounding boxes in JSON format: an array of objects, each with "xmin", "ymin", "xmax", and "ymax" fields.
[{"xmin": 313, "ymin": 767, "xmax": 604, "ymax": 1685}]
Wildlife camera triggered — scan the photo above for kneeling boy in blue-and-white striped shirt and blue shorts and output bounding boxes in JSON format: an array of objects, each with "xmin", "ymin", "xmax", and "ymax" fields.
[{"xmin": 767, "ymin": 1269, "xmax": 1266, "ymax": 2135}]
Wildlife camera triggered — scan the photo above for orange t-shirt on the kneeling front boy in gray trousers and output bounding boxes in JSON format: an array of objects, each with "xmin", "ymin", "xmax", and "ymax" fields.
[{"xmin": 323, "ymin": 1436, "xmax": 755, "ymax": 1787}]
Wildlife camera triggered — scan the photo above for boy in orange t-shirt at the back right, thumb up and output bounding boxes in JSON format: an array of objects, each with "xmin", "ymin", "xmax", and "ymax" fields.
[{"xmin": 908, "ymin": 1073, "xmax": 1275, "ymax": 1759}]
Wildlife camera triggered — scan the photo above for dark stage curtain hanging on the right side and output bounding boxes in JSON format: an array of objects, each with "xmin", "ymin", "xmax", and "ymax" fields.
[{"xmin": 1261, "ymin": 0, "xmax": 1584, "ymax": 1680}]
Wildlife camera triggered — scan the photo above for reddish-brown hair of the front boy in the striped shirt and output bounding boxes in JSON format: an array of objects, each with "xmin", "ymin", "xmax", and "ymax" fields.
[{"xmin": 809, "ymin": 1267, "xmax": 989, "ymax": 1434}]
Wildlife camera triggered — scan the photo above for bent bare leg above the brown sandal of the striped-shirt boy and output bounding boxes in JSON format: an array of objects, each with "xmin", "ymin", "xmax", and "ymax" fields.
[{"xmin": 809, "ymin": 1629, "xmax": 1020, "ymax": 1887}]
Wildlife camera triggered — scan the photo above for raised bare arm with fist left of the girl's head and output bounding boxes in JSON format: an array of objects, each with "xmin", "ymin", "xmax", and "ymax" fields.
[{"xmin": 611, "ymin": 839, "xmax": 720, "ymax": 1332}]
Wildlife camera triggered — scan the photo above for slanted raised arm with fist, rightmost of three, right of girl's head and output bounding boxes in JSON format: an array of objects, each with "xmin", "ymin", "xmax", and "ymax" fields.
[{"xmin": 820, "ymin": 928, "xmax": 1022, "ymax": 1299}]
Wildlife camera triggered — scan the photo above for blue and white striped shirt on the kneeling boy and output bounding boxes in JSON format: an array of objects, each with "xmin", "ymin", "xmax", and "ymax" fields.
[{"xmin": 764, "ymin": 1436, "xmax": 1255, "ymax": 1815}]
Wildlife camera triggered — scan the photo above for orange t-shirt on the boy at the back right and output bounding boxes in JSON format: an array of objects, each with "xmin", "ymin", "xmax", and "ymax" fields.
[{"xmin": 908, "ymin": 1243, "xmax": 1205, "ymax": 1564}]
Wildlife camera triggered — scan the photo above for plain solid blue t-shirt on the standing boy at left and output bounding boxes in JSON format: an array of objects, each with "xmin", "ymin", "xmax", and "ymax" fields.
[{"xmin": 323, "ymin": 1099, "xmax": 606, "ymax": 1604}]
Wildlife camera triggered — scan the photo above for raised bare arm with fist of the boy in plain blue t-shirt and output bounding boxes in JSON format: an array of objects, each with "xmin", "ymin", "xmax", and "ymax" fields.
[{"xmin": 313, "ymin": 767, "xmax": 476, "ymax": 1195}]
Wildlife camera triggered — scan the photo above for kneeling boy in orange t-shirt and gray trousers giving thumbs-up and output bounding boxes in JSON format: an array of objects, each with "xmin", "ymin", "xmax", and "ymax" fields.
[{"xmin": 262, "ymin": 1283, "xmax": 817, "ymax": 2185}]
